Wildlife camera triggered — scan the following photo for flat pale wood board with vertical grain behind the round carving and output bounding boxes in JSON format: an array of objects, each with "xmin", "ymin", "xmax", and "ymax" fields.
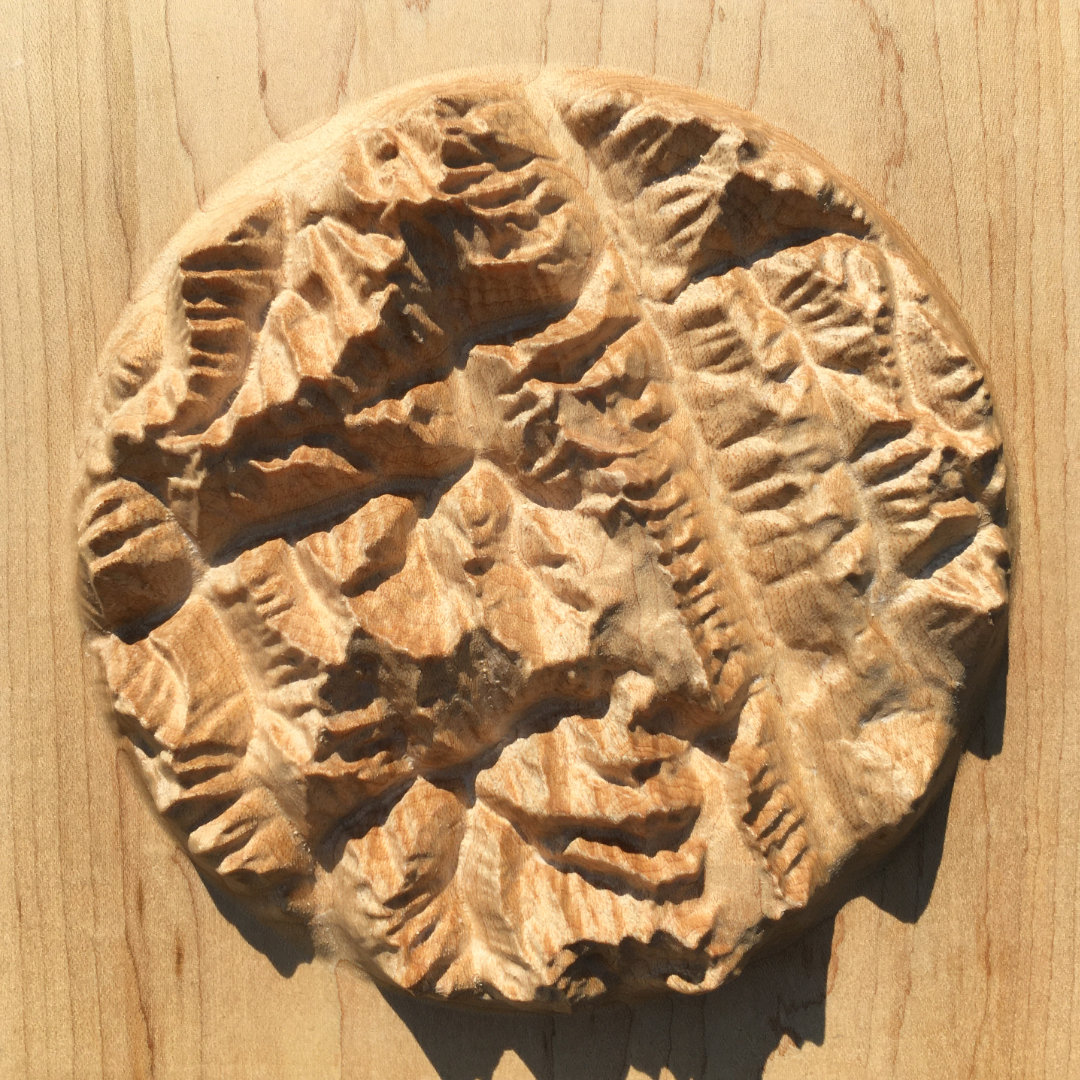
[{"xmin": 0, "ymin": 0, "xmax": 1080, "ymax": 1080}]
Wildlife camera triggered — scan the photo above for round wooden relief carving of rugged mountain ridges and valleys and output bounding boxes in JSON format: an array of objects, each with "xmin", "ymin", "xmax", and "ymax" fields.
[{"xmin": 80, "ymin": 73, "xmax": 1009, "ymax": 1008}]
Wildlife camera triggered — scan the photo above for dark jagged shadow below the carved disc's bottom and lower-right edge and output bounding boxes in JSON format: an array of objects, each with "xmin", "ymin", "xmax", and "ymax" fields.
[{"xmin": 371, "ymin": 650, "xmax": 1008, "ymax": 1080}]
